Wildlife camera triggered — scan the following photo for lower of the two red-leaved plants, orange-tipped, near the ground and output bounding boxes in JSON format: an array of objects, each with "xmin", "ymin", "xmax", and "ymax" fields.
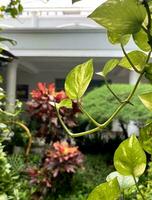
[{"xmin": 27, "ymin": 141, "xmax": 83, "ymax": 195}]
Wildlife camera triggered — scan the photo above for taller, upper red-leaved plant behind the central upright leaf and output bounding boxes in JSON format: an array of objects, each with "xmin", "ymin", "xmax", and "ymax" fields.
[{"xmin": 27, "ymin": 82, "xmax": 79, "ymax": 142}]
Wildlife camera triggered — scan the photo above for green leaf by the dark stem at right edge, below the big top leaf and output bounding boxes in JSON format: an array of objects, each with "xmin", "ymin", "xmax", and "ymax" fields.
[{"xmin": 133, "ymin": 29, "xmax": 151, "ymax": 51}]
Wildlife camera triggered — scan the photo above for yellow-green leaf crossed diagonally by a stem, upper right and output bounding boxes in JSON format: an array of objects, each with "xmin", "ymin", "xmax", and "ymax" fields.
[{"xmin": 119, "ymin": 51, "xmax": 147, "ymax": 71}]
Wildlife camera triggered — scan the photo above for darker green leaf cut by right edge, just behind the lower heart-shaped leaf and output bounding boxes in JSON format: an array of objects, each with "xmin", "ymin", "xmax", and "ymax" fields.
[{"xmin": 139, "ymin": 122, "xmax": 152, "ymax": 154}]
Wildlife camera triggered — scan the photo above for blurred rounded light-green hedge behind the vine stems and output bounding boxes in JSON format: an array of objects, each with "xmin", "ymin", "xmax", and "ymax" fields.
[{"xmin": 79, "ymin": 84, "xmax": 152, "ymax": 124}]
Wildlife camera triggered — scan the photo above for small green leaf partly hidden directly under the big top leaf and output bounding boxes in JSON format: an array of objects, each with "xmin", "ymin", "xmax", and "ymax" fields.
[{"xmin": 107, "ymin": 31, "xmax": 130, "ymax": 45}]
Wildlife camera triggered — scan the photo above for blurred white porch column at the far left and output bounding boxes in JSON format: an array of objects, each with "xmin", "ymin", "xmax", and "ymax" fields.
[{"xmin": 6, "ymin": 60, "xmax": 18, "ymax": 113}]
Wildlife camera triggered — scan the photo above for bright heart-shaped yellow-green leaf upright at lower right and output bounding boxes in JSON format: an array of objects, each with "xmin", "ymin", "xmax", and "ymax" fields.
[{"xmin": 114, "ymin": 135, "xmax": 146, "ymax": 177}]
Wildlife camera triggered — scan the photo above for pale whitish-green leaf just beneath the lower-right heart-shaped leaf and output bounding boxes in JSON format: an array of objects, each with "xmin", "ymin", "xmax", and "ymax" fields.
[{"xmin": 106, "ymin": 171, "xmax": 139, "ymax": 190}]
